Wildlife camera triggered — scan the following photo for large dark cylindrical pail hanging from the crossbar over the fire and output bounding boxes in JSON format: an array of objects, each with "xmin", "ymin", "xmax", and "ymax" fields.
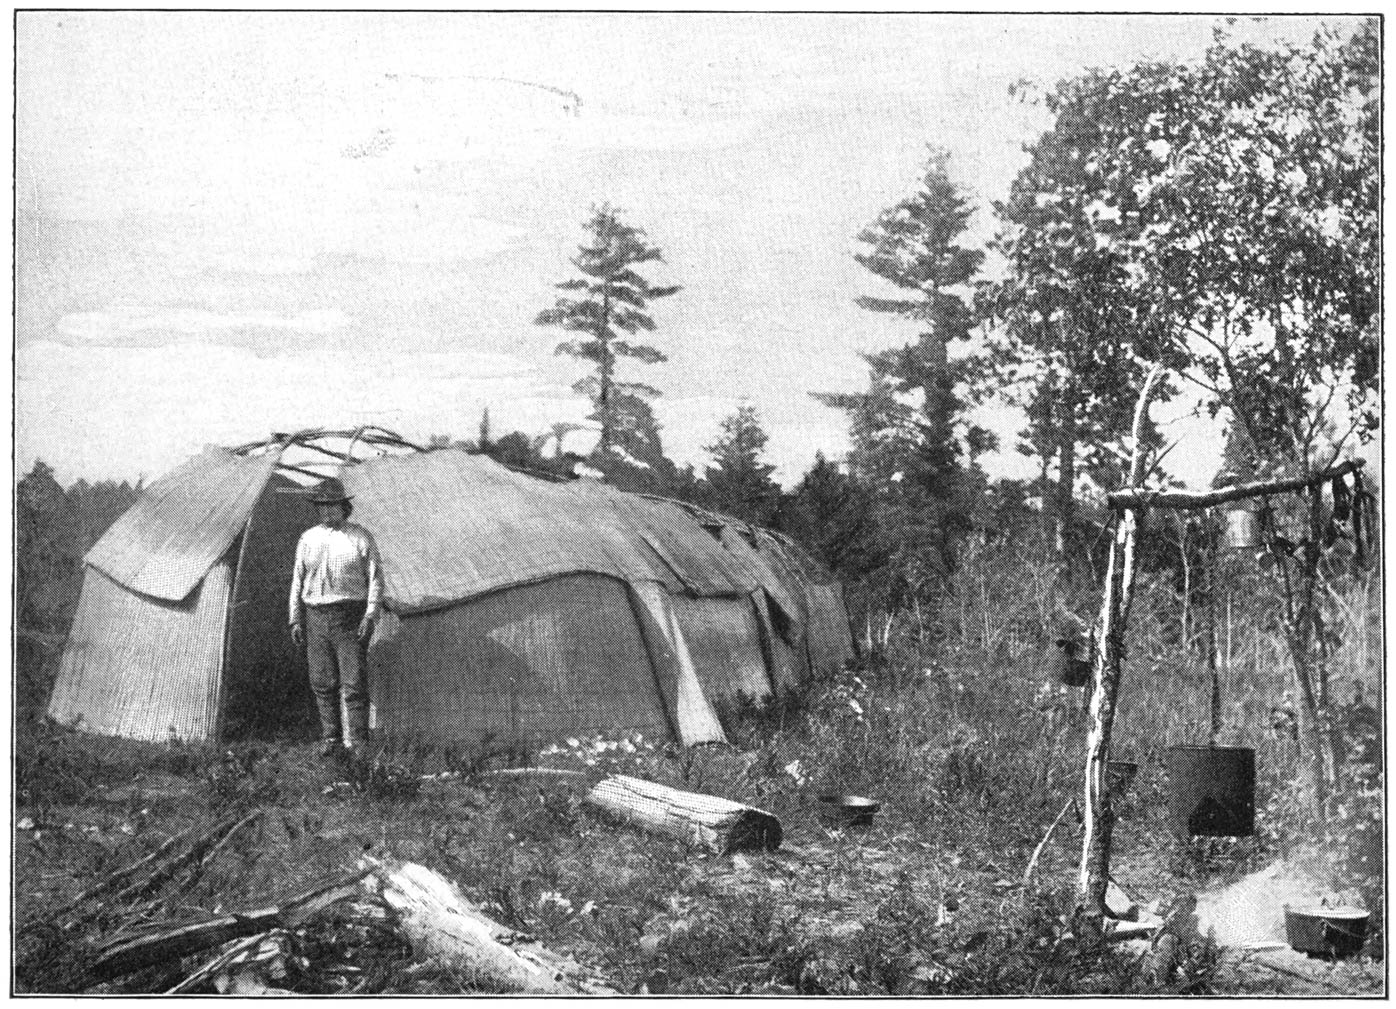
[{"xmin": 1168, "ymin": 747, "xmax": 1255, "ymax": 837}]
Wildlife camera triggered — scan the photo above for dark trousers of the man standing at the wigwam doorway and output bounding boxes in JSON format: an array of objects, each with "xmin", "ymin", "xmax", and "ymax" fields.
[{"xmin": 306, "ymin": 603, "xmax": 369, "ymax": 742}]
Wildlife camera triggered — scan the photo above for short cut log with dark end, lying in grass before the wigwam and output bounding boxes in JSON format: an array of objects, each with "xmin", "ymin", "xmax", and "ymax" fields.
[{"xmin": 586, "ymin": 775, "xmax": 782, "ymax": 853}]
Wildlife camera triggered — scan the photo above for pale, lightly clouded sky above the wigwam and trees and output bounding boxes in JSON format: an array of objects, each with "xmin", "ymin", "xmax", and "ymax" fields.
[{"xmin": 14, "ymin": 11, "xmax": 1362, "ymax": 486}]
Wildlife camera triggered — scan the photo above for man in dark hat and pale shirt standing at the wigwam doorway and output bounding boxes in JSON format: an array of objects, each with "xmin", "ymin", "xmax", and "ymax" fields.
[{"xmin": 290, "ymin": 477, "xmax": 383, "ymax": 756}]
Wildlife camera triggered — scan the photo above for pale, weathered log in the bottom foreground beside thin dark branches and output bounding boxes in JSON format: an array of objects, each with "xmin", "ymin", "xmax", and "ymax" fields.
[{"xmin": 360, "ymin": 855, "xmax": 610, "ymax": 995}]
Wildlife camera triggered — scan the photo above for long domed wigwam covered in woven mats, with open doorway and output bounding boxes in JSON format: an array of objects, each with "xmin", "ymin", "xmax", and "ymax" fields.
[{"xmin": 49, "ymin": 427, "xmax": 853, "ymax": 744}]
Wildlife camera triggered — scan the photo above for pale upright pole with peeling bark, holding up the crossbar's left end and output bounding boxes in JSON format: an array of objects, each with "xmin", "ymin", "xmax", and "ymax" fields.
[{"xmin": 1079, "ymin": 364, "xmax": 1163, "ymax": 920}]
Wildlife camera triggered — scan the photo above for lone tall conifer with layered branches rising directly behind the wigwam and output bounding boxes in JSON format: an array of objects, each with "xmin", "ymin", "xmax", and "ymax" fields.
[{"xmin": 535, "ymin": 204, "xmax": 680, "ymax": 463}]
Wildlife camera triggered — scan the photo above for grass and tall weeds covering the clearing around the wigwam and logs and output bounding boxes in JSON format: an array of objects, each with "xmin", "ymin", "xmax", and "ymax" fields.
[{"xmin": 15, "ymin": 527, "xmax": 1383, "ymax": 995}]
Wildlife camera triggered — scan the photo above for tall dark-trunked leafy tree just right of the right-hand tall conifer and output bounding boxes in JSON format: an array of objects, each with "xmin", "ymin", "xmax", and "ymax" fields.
[{"xmin": 980, "ymin": 72, "xmax": 1171, "ymax": 558}]
